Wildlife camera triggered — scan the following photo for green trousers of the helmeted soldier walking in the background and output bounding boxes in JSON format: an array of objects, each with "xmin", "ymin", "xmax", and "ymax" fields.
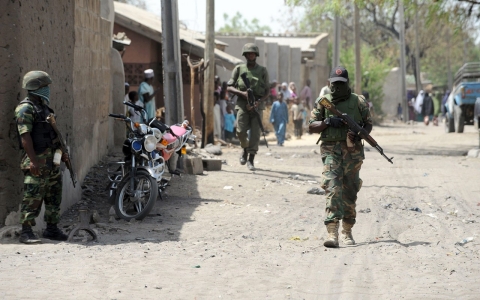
[{"xmin": 237, "ymin": 109, "xmax": 263, "ymax": 154}]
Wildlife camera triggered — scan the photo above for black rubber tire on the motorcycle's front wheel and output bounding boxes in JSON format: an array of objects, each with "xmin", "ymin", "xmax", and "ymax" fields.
[{"xmin": 114, "ymin": 170, "xmax": 158, "ymax": 221}]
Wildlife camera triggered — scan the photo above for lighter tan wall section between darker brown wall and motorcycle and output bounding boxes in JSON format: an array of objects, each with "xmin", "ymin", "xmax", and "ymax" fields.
[{"xmin": 73, "ymin": 0, "xmax": 113, "ymax": 198}]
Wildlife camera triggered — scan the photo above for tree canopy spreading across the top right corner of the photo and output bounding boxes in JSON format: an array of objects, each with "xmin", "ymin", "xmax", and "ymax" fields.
[{"xmin": 287, "ymin": 0, "xmax": 480, "ymax": 89}]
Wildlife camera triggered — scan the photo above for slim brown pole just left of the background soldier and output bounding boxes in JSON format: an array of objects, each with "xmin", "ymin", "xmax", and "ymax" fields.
[{"xmin": 202, "ymin": 0, "xmax": 215, "ymax": 148}]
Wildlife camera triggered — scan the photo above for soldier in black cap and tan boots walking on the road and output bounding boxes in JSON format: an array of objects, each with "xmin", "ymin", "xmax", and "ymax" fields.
[{"xmin": 309, "ymin": 67, "xmax": 373, "ymax": 247}]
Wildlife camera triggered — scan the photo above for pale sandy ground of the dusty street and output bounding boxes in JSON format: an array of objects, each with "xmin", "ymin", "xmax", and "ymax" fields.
[{"xmin": 0, "ymin": 120, "xmax": 480, "ymax": 299}]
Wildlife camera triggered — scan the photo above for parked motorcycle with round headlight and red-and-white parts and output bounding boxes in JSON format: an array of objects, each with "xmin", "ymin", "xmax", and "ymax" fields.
[{"xmin": 108, "ymin": 102, "xmax": 195, "ymax": 221}]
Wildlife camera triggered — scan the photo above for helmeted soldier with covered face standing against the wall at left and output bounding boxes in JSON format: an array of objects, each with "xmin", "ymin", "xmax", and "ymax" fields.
[{"xmin": 15, "ymin": 71, "xmax": 68, "ymax": 244}]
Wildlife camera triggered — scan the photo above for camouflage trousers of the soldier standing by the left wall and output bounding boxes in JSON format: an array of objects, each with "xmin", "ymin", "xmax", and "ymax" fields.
[{"xmin": 20, "ymin": 169, "xmax": 62, "ymax": 226}]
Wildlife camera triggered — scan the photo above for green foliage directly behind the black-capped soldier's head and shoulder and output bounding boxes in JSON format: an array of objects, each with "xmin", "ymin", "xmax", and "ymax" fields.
[{"xmin": 340, "ymin": 45, "xmax": 394, "ymax": 114}]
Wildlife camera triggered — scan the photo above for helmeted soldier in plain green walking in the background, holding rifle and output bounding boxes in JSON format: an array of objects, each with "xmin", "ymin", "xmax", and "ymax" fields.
[{"xmin": 227, "ymin": 43, "xmax": 270, "ymax": 171}]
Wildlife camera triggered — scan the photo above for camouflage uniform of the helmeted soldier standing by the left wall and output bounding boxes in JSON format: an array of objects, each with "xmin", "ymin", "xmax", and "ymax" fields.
[{"xmin": 15, "ymin": 101, "xmax": 62, "ymax": 226}]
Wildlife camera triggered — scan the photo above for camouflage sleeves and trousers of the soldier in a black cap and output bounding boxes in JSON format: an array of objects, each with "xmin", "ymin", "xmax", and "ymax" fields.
[{"xmin": 309, "ymin": 93, "xmax": 372, "ymax": 225}]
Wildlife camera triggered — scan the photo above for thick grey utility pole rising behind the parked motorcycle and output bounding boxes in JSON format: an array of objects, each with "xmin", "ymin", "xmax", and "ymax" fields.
[{"xmin": 161, "ymin": 0, "xmax": 184, "ymax": 125}]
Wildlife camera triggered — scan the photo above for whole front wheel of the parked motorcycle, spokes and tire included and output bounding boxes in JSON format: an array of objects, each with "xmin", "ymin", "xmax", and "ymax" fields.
[{"xmin": 114, "ymin": 170, "xmax": 158, "ymax": 221}]
